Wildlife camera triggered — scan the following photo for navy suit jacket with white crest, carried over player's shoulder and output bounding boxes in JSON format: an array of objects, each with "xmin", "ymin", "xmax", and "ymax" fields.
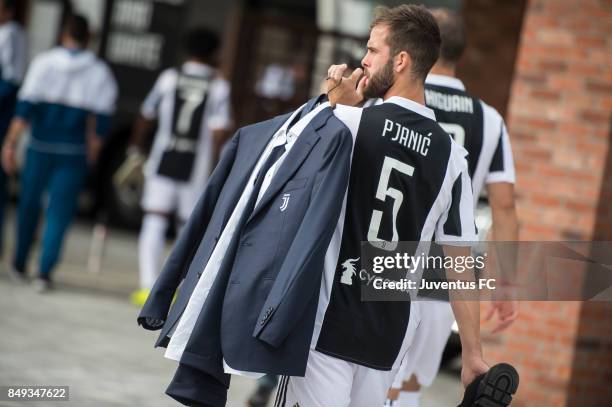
[{"xmin": 138, "ymin": 100, "xmax": 353, "ymax": 380}]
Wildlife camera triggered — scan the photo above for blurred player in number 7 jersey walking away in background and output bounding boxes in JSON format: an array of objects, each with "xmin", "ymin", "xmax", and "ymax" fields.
[{"xmin": 119, "ymin": 28, "xmax": 232, "ymax": 305}]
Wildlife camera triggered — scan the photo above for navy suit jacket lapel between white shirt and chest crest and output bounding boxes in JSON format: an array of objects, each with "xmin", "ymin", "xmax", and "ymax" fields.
[{"xmin": 247, "ymin": 108, "xmax": 332, "ymax": 223}]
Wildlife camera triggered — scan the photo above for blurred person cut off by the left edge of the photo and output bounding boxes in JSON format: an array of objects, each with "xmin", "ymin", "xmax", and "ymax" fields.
[{"xmin": 0, "ymin": 0, "xmax": 27, "ymax": 262}]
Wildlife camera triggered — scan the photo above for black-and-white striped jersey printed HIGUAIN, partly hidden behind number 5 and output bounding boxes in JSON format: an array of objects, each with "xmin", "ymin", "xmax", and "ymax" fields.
[{"xmin": 425, "ymin": 74, "xmax": 515, "ymax": 203}]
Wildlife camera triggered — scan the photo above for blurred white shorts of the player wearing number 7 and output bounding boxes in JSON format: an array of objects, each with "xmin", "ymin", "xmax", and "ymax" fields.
[{"xmin": 141, "ymin": 174, "xmax": 206, "ymax": 221}]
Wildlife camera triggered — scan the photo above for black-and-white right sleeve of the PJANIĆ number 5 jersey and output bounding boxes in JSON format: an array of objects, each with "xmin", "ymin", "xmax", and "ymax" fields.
[{"xmin": 436, "ymin": 166, "xmax": 478, "ymax": 246}]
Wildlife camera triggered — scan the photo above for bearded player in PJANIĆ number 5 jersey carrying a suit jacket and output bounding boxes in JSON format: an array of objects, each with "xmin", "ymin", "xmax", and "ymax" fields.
[{"xmin": 275, "ymin": 5, "xmax": 488, "ymax": 407}]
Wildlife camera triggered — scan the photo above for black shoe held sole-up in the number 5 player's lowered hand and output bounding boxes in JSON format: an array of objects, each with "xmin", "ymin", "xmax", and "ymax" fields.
[{"xmin": 458, "ymin": 363, "xmax": 519, "ymax": 407}]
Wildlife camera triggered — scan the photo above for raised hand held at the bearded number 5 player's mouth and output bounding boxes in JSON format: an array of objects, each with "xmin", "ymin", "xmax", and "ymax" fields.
[{"xmin": 325, "ymin": 64, "xmax": 368, "ymax": 106}]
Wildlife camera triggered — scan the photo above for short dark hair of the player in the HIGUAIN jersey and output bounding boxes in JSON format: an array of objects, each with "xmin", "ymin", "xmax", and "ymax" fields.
[{"xmin": 431, "ymin": 8, "xmax": 466, "ymax": 65}]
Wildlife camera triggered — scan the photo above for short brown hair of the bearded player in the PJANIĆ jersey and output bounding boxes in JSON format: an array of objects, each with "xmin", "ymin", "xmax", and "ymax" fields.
[{"xmin": 370, "ymin": 4, "xmax": 441, "ymax": 80}]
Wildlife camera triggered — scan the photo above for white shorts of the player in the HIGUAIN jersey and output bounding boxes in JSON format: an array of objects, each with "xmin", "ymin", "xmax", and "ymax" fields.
[{"xmin": 393, "ymin": 300, "xmax": 455, "ymax": 389}]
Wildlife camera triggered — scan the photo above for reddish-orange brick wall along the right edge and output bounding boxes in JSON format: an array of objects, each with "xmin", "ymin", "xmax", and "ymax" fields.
[{"xmin": 484, "ymin": 0, "xmax": 612, "ymax": 407}]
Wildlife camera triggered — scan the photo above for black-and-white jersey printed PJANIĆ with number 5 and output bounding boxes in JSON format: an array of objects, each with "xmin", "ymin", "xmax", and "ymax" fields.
[{"xmin": 312, "ymin": 97, "xmax": 476, "ymax": 370}]
